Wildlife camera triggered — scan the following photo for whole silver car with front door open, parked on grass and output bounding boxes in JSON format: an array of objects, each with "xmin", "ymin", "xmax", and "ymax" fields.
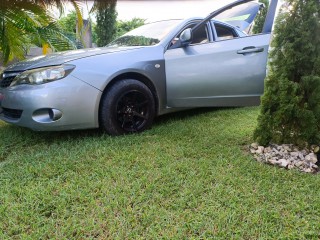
[{"xmin": 0, "ymin": 0, "xmax": 277, "ymax": 135}]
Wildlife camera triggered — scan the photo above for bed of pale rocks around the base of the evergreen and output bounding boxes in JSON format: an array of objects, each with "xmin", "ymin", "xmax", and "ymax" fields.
[{"xmin": 249, "ymin": 143, "xmax": 319, "ymax": 173}]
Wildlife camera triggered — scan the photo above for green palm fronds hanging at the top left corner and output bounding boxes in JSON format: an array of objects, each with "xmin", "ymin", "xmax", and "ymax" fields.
[{"xmin": 0, "ymin": 0, "xmax": 82, "ymax": 64}]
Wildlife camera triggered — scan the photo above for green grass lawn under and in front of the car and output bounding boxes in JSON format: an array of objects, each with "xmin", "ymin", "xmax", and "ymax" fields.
[{"xmin": 0, "ymin": 108, "xmax": 320, "ymax": 239}]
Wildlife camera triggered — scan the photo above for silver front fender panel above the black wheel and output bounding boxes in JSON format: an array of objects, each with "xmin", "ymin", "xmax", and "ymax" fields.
[{"xmin": 70, "ymin": 45, "xmax": 166, "ymax": 114}]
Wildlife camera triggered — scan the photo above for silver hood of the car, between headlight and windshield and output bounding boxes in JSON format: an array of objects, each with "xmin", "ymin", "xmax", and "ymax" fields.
[{"xmin": 5, "ymin": 46, "xmax": 143, "ymax": 72}]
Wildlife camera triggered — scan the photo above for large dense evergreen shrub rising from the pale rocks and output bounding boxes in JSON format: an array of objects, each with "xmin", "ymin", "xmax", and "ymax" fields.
[{"xmin": 254, "ymin": 0, "xmax": 320, "ymax": 145}]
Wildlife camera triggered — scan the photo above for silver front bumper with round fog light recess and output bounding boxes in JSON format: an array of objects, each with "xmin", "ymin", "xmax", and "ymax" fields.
[{"xmin": 0, "ymin": 75, "xmax": 102, "ymax": 131}]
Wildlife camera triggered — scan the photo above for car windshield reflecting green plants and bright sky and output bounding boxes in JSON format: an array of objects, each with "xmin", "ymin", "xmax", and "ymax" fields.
[{"xmin": 107, "ymin": 20, "xmax": 181, "ymax": 47}]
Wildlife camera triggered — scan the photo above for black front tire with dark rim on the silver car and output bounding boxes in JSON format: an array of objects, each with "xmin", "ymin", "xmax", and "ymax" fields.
[{"xmin": 99, "ymin": 79, "xmax": 155, "ymax": 136}]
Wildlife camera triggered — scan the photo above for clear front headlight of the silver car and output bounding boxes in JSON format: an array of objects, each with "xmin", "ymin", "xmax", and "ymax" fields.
[{"xmin": 10, "ymin": 65, "xmax": 75, "ymax": 87}]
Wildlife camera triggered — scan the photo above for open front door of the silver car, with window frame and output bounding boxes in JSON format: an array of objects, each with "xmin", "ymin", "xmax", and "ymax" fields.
[{"xmin": 164, "ymin": 0, "xmax": 277, "ymax": 107}]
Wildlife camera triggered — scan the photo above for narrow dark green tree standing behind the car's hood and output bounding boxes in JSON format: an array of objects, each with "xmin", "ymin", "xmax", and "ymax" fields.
[{"xmin": 95, "ymin": 0, "xmax": 117, "ymax": 47}]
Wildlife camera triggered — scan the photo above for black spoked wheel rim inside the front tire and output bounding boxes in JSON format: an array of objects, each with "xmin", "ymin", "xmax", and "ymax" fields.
[{"xmin": 116, "ymin": 90, "xmax": 149, "ymax": 132}]
